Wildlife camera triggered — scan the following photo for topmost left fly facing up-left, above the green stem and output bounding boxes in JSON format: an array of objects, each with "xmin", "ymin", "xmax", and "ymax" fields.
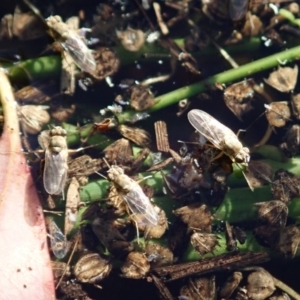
[{"xmin": 46, "ymin": 16, "xmax": 96, "ymax": 73}]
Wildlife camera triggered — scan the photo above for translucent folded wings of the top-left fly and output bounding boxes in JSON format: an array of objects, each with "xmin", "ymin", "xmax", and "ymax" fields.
[{"xmin": 61, "ymin": 36, "xmax": 96, "ymax": 73}]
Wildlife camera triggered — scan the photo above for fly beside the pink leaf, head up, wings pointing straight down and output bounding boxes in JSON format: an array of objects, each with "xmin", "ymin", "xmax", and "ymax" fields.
[{"xmin": 38, "ymin": 126, "xmax": 68, "ymax": 195}]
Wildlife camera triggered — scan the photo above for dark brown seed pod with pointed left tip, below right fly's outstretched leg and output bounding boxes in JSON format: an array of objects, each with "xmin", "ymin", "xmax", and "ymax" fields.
[{"xmin": 256, "ymin": 200, "xmax": 288, "ymax": 227}]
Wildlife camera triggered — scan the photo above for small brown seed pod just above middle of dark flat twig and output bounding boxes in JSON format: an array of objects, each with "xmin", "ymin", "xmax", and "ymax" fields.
[{"xmin": 191, "ymin": 232, "xmax": 219, "ymax": 256}]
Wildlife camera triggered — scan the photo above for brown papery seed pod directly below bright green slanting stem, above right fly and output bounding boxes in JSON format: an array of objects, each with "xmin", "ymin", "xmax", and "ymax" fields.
[{"xmin": 224, "ymin": 79, "xmax": 255, "ymax": 120}]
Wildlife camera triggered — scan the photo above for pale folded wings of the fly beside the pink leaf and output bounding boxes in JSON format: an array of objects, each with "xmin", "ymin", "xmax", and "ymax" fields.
[{"xmin": 43, "ymin": 149, "xmax": 68, "ymax": 195}]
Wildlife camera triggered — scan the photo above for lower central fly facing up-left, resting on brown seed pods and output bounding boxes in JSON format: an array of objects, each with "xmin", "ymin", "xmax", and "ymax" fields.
[{"xmin": 107, "ymin": 161, "xmax": 159, "ymax": 238}]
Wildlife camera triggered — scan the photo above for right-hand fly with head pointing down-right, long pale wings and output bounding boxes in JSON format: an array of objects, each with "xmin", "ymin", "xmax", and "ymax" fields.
[{"xmin": 188, "ymin": 109, "xmax": 250, "ymax": 166}]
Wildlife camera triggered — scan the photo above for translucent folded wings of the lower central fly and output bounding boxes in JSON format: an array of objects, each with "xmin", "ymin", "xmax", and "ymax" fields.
[{"xmin": 124, "ymin": 186, "xmax": 158, "ymax": 226}]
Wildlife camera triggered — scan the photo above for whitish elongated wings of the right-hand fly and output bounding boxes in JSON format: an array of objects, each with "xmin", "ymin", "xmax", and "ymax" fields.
[{"xmin": 188, "ymin": 109, "xmax": 236, "ymax": 150}]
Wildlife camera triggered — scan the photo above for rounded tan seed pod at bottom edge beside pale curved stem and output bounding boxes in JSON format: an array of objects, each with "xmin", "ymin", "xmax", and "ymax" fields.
[{"xmin": 247, "ymin": 268, "xmax": 276, "ymax": 300}]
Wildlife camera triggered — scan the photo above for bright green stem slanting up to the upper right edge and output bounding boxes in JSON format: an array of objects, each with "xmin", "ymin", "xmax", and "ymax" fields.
[{"xmin": 118, "ymin": 46, "xmax": 300, "ymax": 123}]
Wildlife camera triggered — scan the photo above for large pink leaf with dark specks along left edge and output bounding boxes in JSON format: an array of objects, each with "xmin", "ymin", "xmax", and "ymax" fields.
[{"xmin": 0, "ymin": 72, "xmax": 55, "ymax": 300}]
